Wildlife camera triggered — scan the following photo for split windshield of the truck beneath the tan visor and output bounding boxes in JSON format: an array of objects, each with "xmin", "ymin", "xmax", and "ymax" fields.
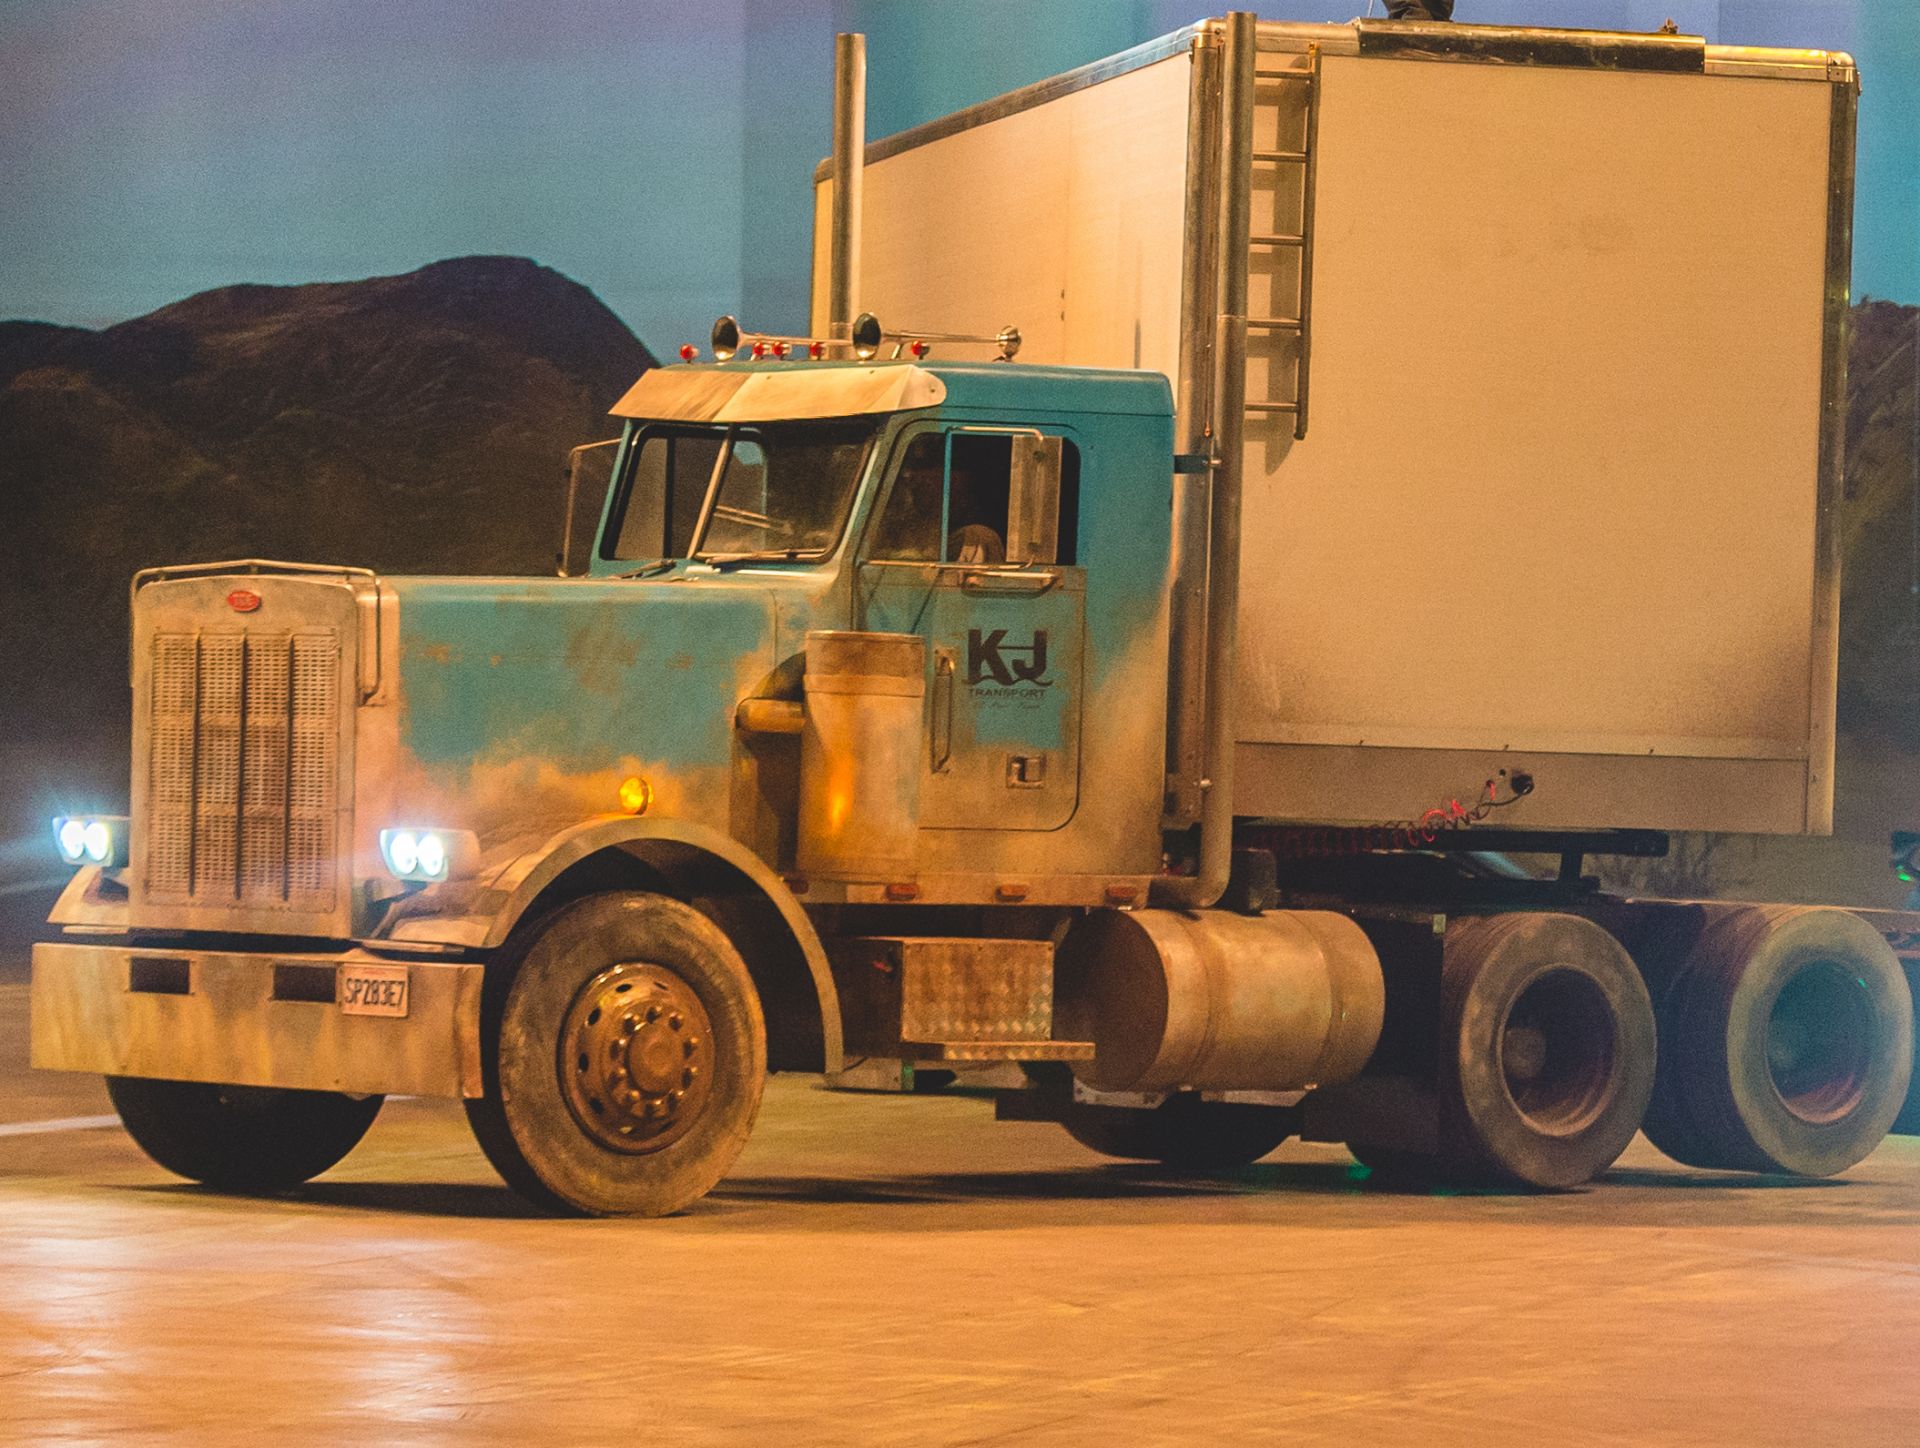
[{"xmin": 601, "ymin": 417, "xmax": 879, "ymax": 561}]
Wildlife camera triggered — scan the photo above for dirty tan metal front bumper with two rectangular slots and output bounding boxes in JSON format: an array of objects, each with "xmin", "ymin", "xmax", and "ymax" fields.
[{"xmin": 29, "ymin": 943, "xmax": 484, "ymax": 1097}]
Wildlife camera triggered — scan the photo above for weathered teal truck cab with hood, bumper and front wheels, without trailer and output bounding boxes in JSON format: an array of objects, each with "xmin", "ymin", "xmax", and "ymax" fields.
[{"xmin": 33, "ymin": 361, "xmax": 1244, "ymax": 1212}]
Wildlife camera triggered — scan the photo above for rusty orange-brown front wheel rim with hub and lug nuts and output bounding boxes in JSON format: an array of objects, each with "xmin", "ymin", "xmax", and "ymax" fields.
[{"xmin": 559, "ymin": 962, "xmax": 714, "ymax": 1154}]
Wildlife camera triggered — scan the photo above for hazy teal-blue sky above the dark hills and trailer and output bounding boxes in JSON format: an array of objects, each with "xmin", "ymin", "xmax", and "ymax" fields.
[{"xmin": 0, "ymin": 0, "xmax": 1920, "ymax": 351}]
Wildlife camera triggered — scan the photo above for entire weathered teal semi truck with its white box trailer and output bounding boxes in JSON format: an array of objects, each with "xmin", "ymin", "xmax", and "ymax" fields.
[{"xmin": 31, "ymin": 13, "xmax": 1914, "ymax": 1216}]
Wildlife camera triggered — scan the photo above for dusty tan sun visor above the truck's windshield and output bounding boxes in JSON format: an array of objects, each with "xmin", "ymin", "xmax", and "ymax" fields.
[{"xmin": 612, "ymin": 363, "xmax": 947, "ymax": 422}]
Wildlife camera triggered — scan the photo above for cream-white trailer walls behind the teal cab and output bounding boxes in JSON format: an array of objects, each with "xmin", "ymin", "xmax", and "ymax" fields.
[{"xmin": 816, "ymin": 25, "xmax": 1847, "ymax": 832}]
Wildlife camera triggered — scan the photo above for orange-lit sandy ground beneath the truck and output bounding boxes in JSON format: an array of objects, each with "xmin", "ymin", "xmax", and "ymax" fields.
[{"xmin": 0, "ymin": 964, "xmax": 1920, "ymax": 1444}]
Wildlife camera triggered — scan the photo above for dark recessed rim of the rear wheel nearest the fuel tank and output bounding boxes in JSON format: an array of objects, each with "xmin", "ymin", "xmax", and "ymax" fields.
[{"xmin": 1500, "ymin": 968, "xmax": 1619, "ymax": 1137}]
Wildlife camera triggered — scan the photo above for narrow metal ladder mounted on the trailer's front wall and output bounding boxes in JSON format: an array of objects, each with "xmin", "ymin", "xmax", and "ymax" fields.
[{"xmin": 1246, "ymin": 46, "xmax": 1321, "ymax": 438}]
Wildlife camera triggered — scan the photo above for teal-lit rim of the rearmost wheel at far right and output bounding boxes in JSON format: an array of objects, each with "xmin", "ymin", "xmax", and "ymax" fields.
[{"xmin": 1766, "ymin": 960, "xmax": 1874, "ymax": 1125}]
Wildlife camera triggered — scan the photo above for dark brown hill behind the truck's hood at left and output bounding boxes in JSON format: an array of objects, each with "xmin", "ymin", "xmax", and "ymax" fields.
[{"xmin": 0, "ymin": 257, "xmax": 653, "ymax": 856}]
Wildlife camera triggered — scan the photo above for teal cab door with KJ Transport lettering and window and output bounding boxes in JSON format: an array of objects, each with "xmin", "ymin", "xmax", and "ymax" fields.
[{"xmin": 854, "ymin": 426, "xmax": 1087, "ymax": 830}]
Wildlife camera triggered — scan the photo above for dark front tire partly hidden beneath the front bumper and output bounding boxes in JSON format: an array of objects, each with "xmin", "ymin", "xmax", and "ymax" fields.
[{"xmin": 108, "ymin": 1075, "xmax": 386, "ymax": 1193}]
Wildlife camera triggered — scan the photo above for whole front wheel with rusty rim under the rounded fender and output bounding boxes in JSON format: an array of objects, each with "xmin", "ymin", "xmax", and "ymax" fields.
[{"xmin": 467, "ymin": 891, "xmax": 766, "ymax": 1216}]
